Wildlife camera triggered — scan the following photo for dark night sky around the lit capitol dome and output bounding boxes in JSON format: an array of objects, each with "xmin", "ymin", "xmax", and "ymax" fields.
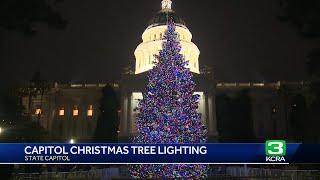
[{"xmin": 0, "ymin": 0, "xmax": 315, "ymax": 84}]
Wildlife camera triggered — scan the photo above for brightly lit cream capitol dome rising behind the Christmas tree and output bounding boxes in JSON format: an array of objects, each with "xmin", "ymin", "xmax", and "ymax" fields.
[{"xmin": 134, "ymin": 0, "xmax": 200, "ymax": 74}]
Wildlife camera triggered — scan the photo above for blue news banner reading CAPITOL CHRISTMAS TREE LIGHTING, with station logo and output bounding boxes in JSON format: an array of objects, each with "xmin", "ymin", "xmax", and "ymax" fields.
[{"xmin": 0, "ymin": 140, "xmax": 320, "ymax": 164}]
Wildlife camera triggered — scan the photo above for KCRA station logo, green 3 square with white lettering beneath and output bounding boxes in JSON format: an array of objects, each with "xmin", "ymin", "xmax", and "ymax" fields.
[{"xmin": 265, "ymin": 140, "xmax": 287, "ymax": 163}]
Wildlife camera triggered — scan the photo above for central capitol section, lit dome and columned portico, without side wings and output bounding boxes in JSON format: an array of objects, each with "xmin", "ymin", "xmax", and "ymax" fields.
[{"xmin": 120, "ymin": 0, "xmax": 218, "ymax": 139}]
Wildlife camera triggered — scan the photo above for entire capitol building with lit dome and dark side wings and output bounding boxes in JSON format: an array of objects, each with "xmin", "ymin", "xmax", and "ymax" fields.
[{"xmin": 23, "ymin": 0, "xmax": 302, "ymax": 142}]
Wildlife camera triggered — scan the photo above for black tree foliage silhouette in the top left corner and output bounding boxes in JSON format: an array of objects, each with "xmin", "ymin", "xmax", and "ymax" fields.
[{"xmin": 0, "ymin": 0, "xmax": 66, "ymax": 35}]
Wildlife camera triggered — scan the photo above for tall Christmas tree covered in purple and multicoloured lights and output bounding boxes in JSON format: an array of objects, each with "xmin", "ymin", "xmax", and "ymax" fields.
[{"xmin": 130, "ymin": 22, "xmax": 208, "ymax": 179}]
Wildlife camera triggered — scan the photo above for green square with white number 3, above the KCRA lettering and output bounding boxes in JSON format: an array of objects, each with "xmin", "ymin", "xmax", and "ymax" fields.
[{"xmin": 265, "ymin": 140, "xmax": 287, "ymax": 156}]
